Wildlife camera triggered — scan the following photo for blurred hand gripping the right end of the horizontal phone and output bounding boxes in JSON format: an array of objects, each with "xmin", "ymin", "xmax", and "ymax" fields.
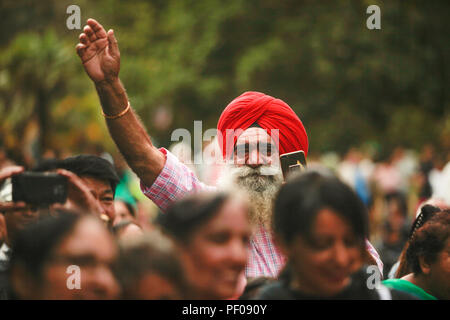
[{"xmin": 56, "ymin": 169, "xmax": 103, "ymax": 215}]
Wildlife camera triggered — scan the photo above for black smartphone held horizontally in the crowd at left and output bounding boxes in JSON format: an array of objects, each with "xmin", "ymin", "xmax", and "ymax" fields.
[{"xmin": 11, "ymin": 172, "xmax": 67, "ymax": 205}]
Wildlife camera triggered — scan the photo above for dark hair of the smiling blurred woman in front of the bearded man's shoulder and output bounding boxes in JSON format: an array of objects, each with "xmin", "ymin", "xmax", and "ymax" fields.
[{"xmin": 156, "ymin": 193, "xmax": 228, "ymax": 241}]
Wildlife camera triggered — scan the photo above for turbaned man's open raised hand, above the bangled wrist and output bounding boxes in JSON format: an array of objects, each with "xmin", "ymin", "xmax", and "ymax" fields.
[{"xmin": 76, "ymin": 19, "xmax": 120, "ymax": 83}]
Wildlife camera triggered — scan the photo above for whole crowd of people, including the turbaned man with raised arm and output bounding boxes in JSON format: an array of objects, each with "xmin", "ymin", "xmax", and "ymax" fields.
[{"xmin": 0, "ymin": 19, "xmax": 450, "ymax": 300}]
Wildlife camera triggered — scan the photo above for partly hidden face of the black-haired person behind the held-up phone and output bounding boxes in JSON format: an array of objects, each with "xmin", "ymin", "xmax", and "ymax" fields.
[{"xmin": 80, "ymin": 176, "xmax": 115, "ymax": 221}]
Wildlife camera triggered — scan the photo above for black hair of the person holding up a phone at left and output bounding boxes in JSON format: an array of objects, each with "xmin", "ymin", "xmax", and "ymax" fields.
[{"xmin": 33, "ymin": 154, "xmax": 119, "ymax": 194}]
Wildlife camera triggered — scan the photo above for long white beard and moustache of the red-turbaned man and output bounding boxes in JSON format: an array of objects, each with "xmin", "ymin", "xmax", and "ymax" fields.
[{"xmin": 217, "ymin": 165, "xmax": 283, "ymax": 229}]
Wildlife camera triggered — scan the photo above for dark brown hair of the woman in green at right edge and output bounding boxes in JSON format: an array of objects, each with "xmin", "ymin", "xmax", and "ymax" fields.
[{"xmin": 406, "ymin": 210, "xmax": 450, "ymax": 274}]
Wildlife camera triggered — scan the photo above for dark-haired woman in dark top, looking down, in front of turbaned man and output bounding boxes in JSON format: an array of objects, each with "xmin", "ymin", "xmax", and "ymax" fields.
[{"xmin": 256, "ymin": 171, "xmax": 414, "ymax": 300}]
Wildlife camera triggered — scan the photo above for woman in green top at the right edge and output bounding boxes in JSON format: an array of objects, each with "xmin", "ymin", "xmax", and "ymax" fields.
[{"xmin": 382, "ymin": 210, "xmax": 450, "ymax": 300}]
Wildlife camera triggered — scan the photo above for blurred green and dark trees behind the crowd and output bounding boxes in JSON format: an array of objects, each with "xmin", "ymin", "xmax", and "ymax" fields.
[{"xmin": 0, "ymin": 0, "xmax": 450, "ymax": 165}]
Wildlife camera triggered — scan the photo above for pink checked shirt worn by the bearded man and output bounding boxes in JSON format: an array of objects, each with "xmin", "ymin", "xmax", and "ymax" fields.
[{"xmin": 141, "ymin": 148, "xmax": 383, "ymax": 278}]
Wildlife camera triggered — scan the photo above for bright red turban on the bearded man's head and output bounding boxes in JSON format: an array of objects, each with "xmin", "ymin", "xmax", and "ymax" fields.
[{"xmin": 217, "ymin": 91, "xmax": 308, "ymax": 158}]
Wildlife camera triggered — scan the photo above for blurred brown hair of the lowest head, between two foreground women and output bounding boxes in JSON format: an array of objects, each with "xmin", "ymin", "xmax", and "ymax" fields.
[{"xmin": 115, "ymin": 232, "xmax": 187, "ymax": 299}]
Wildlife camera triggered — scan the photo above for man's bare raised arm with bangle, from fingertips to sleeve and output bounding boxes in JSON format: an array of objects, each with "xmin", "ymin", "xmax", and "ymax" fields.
[{"xmin": 76, "ymin": 19, "xmax": 165, "ymax": 186}]
